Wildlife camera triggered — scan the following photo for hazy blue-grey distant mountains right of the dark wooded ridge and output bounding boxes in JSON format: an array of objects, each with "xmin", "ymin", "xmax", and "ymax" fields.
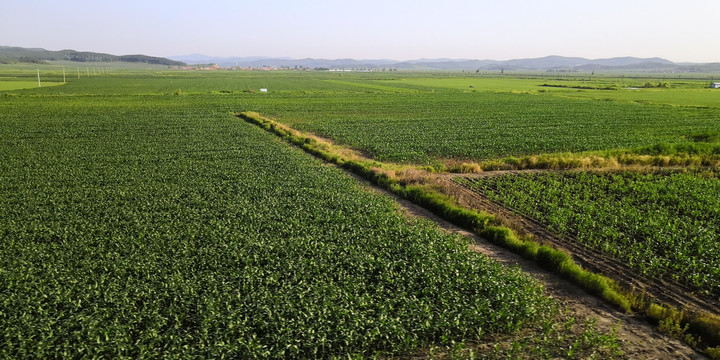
[{"xmin": 169, "ymin": 54, "xmax": 720, "ymax": 72}]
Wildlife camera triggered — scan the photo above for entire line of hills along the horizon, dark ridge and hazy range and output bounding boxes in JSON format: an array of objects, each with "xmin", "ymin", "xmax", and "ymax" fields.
[{"xmin": 0, "ymin": 46, "xmax": 720, "ymax": 73}]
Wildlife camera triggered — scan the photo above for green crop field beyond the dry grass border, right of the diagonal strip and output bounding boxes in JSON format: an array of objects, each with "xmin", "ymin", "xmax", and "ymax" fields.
[{"xmin": 245, "ymin": 91, "xmax": 720, "ymax": 163}]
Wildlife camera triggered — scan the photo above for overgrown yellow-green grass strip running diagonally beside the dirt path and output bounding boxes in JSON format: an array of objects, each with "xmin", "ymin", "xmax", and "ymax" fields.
[{"xmin": 239, "ymin": 112, "xmax": 720, "ymax": 359}]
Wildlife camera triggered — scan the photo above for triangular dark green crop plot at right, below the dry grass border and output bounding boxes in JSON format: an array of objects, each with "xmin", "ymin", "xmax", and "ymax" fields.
[{"xmin": 458, "ymin": 172, "xmax": 720, "ymax": 297}]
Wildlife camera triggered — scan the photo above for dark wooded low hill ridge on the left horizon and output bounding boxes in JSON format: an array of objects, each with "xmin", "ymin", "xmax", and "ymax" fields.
[{"xmin": 0, "ymin": 46, "xmax": 186, "ymax": 66}]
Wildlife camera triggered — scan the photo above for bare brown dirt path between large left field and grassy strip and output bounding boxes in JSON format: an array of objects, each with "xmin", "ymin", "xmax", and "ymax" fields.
[{"xmin": 356, "ymin": 176, "xmax": 706, "ymax": 359}]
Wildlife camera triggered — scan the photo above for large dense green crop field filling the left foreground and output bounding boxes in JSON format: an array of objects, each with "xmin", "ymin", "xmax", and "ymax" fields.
[{"xmin": 0, "ymin": 90, "xmax": 595, "ymax": 358}]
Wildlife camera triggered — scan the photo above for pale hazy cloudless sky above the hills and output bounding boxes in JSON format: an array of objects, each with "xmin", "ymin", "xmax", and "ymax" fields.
[{"xmin": 0, "ymin": 0, "xmax": 720, "ymax": 62}]
